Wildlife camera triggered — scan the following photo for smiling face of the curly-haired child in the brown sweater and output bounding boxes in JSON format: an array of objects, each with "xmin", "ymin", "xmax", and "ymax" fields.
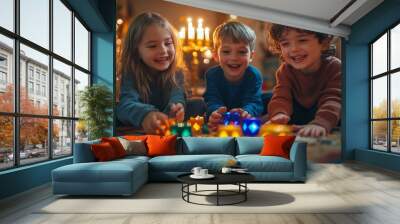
[{"xmin": 279, "ymin": 29, "xmax": 324, "ymax": 73}]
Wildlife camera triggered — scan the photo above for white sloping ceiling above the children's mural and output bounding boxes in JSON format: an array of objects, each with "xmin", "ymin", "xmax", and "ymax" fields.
[{"xmin": 167, "ymin": 0, "xmax": 383, "ymax": 37}]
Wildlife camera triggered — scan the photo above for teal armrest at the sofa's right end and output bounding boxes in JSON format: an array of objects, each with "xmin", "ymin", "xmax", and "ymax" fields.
[{"xmin": 290, "ymin": 141, "xmax": 307, "ymax": 181}]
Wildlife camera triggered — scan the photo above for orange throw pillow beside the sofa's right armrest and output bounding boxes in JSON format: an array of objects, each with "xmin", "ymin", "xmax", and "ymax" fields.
[{"xmin": 260, "ymin": 135, "xmax": 296, "ymax": 159}]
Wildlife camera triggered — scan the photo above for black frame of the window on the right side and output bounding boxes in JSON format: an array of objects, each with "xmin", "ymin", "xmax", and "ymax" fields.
[{"xmin": 368, "ymin": 21, "xmax": 400, "ymax": 155}]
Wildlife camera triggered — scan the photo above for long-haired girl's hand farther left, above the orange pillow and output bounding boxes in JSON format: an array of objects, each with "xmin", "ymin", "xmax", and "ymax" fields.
[{"xmin": 142, "ymin": 111, "xmax": 168, "ymax": 134}]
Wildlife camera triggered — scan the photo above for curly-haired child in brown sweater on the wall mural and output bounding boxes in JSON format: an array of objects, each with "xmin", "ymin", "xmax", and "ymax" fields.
[{"xmin": 268, "ymin": 24, "xmax": 342, "ymax": 137}]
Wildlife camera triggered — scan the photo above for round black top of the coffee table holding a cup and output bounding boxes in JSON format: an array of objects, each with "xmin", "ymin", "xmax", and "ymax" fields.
[{"xmin": 177, "ymin": 173, "xmax": 255, "ymax": 184}]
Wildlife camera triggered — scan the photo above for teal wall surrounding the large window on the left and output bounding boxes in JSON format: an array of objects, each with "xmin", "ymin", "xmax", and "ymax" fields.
[{"xmin": 0, "ymin": 0, "xmax": 115, "ymax": 199}]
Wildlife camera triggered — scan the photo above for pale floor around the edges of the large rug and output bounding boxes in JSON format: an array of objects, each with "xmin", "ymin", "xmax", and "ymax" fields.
[{"xmin": 0, "ymin": 163, "xmax": 400, "ymax": 224}]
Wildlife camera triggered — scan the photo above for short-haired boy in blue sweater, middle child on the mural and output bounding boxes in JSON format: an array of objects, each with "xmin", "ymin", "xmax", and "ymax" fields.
[{"xmin": 204, "ymin": 21, "xmax": 263, "ymax": 131}]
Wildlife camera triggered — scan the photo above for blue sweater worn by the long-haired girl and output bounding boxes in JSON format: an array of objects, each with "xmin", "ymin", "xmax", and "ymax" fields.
[{"xmin": 116, "ymin": 73, "xmax": 185, "ymax": 128}]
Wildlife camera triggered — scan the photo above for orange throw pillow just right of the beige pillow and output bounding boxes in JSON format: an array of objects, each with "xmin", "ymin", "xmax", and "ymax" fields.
[{"xmin": 146, "ymin": 135, "xmax": 176, "ymax": 156}]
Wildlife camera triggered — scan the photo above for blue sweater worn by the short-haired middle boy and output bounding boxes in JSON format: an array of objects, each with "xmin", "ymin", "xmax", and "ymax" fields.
[{"xmin": 204, "ymin": 65, "xmax": 264, "ymax": 117}]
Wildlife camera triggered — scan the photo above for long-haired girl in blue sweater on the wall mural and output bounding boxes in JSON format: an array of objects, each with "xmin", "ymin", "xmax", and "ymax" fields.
[{"xmin": 116, "ymin": 12, "xmax": 185, "ymax": 134}]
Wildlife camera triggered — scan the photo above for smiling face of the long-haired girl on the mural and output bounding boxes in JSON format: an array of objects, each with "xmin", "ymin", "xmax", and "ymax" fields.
[{"xmin": 139, "ymin": 25, "xmax": 175, "ymax": 72}]
